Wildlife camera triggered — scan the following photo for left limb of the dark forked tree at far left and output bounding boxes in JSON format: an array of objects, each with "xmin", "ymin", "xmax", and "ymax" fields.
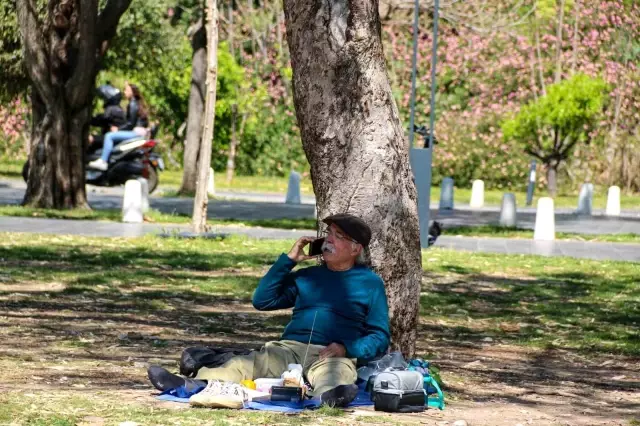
[{"xmin": 16, "ymin": 0, "xmax": 52, "ymax": 103}]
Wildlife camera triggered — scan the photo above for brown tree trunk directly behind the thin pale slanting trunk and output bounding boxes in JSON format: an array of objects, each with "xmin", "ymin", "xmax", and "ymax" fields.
[{"xmin": 179, "ymin": 22, "xmax": 207, "ymax": 195}]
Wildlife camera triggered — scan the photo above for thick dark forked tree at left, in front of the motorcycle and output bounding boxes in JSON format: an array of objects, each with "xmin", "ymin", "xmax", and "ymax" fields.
[{"xmin": 16, "ymin": 0, "xmax": 131, "ymax": 208}]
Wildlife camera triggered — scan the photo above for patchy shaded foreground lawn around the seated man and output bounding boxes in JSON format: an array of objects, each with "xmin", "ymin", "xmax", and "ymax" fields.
[{"xmin": 0, "ymin": 234, "xmax": 640, "ymax": 426}]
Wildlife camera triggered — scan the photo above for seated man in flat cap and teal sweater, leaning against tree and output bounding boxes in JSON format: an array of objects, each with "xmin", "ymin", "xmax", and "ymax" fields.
[{"xmin": 149, "ymin": 214, "xmax": 389, "ymax": 406}]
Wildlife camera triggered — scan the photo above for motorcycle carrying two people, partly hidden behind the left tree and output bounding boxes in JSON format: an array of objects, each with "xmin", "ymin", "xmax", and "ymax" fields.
[{"xmin": 22, "ymin": 125, "xmax": 164, "ymax": 193}]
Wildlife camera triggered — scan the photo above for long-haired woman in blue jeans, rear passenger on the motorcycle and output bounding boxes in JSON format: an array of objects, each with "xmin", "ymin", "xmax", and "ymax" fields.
[{"xmin": 88, "ymin": 82, "xmax": 149, "ymax": 171}]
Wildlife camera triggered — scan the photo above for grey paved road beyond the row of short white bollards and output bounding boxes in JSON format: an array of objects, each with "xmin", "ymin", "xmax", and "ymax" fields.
[{"xmin": 0, "ymin": 180, "xmax": 640, "ymax": 234}]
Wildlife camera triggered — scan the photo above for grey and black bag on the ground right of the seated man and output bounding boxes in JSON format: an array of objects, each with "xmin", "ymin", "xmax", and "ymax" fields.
[{"xmin": 372, "ymin": 370, "xmax": 426, "ymax": 413}]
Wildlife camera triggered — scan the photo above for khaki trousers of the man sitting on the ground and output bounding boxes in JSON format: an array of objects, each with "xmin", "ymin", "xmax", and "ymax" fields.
[{"xmin": 196, "ymin": 340, "xmax": 358, "ymax": 395}]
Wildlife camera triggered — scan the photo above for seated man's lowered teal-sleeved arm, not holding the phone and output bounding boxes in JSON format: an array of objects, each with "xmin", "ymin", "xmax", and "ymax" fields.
[{"xmin": 341, "ymin": 284, "xmax": 390, "ymax": 359}]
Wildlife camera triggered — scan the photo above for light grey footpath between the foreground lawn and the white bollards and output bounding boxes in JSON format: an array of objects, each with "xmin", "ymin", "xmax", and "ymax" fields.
[{"xmin": 0, "ymin": 217, "xmax": 640, "ymax": 262}]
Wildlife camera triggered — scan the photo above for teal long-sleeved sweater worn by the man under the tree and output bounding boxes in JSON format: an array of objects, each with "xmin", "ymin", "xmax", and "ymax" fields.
[{"xmin": 253, "ymin": 254, "xmax": 389, "ymax": 359}]
